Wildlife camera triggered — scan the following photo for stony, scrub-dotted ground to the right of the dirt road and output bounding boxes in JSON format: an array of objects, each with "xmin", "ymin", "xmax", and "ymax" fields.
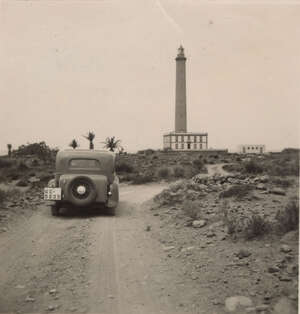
[{"xmin": 151, "ymin": 166, "xmax": 299, "ymax": 314}]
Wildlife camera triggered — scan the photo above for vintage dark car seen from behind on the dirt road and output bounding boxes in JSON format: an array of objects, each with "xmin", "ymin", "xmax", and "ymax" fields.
[{"xmin": 44, "ymin": 149, "xmax": 119, "ymax": 216}]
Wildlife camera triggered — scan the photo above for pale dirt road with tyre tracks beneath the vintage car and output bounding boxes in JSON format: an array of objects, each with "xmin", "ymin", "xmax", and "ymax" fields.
[{"xmin": 0, "ymin": 184, "xmax": 202, "ymax": 314}]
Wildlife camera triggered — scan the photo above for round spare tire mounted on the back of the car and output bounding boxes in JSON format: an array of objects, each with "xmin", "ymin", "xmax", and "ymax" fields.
[{"xmin": 68, "ymin": 177, "xmax": 97, "ymax": 206}]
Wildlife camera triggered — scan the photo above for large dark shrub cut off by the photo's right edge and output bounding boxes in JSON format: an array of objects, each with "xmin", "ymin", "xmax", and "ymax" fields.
[{"xmin": 276, "ymin": 198, "xmax": 299, "ymax": 232}]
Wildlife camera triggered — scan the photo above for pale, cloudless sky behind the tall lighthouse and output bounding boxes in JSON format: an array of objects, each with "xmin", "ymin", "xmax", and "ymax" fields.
[{"xmin": 0, "ymin": 0, "xmax": 300, "ymax": 152}]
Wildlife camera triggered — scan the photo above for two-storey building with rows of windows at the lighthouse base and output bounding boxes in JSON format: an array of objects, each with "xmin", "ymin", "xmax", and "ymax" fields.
[{"xmin": 164, "ymin": 132, "xmax": 208, "ymax": 151}]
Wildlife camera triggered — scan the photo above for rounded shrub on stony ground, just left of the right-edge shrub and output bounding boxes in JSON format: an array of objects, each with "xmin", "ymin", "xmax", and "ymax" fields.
[{"xmin": 243, "ymin": 214, "xmax": 271, "ymax": 240}]
